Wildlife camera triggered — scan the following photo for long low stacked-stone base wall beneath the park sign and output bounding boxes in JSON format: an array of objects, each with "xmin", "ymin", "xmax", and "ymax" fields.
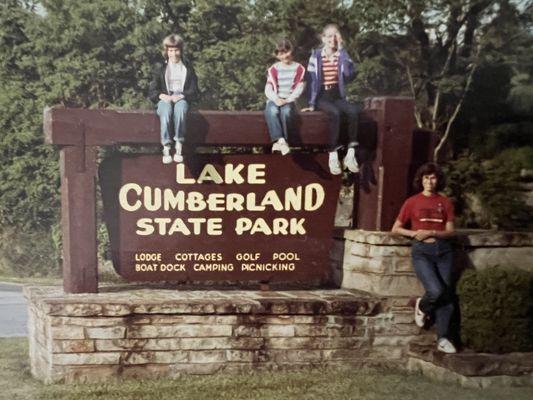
[{"xmin": 25, "ymin": 287, "xmax": 418, "ymax": 383}]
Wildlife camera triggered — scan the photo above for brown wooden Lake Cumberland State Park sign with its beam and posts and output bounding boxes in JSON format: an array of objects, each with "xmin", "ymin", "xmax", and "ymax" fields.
[{"xmin": 44, "ymin": 98, "xmax": 413, "ymax": 293}]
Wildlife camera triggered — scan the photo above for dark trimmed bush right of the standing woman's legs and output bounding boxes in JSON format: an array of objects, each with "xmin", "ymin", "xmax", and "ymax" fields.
[{"xmin": 457, "ymin": 267, "xmax": 533, "ymax": 353}]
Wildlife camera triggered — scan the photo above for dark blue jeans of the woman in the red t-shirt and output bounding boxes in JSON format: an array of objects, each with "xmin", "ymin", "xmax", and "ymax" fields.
[{"xmin": 411, "ymin": 239, "xmax": 454, "ymax": 339}]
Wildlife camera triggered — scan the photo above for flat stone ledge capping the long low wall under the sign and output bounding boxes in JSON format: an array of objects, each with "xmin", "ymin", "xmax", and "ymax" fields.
[{"xmin": 24, "ymin": 286, "xmax": 383, "ymax": 317}]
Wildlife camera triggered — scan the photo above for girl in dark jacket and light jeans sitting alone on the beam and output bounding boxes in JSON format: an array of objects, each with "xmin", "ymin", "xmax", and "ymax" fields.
[{"xmin": 149, "ymin": 34, "xmax": 198, "ymax": 164}]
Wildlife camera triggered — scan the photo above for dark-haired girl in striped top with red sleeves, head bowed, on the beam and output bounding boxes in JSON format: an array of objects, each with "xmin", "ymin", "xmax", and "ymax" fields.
[{"xmin": 265, "ymin": 39, "xmax": 305, "ymax": 155}]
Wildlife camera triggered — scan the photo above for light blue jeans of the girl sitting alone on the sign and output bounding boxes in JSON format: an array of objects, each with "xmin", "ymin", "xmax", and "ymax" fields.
[{"xmin": 157, "ymin": 99, "xmax": 189, "ymax": 146}]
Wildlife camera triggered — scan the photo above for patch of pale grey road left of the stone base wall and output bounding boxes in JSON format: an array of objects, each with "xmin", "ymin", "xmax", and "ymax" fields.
[{"xmin": 0, "ymin": 282, "xmax": 28, "ymax": 337}]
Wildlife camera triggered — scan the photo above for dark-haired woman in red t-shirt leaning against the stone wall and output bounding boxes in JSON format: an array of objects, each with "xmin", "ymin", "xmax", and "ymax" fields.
[{"xmin": 392, "ymin": 163, "xmax": 456, "ymax": 353}]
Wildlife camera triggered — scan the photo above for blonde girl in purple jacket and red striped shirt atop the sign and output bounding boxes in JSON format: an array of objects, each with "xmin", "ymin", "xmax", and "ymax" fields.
[{"xmin": 302, "ymin": 24, "xmax": 359, "ymax": 175}]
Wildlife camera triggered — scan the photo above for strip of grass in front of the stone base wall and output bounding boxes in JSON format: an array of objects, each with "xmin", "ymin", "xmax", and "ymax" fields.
[{"xmin": 0, "ymin": 338, "xmax": 533, "ymax": 400}]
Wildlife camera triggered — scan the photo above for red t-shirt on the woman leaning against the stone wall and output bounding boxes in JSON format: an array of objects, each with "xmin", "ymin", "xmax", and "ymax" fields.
[{"xmin": 396, "ymin": 193, "xmax": 455, "ymax": 231}]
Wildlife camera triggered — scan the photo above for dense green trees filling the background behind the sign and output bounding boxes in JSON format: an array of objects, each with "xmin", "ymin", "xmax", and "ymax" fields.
[{"xmin": 0, "ymin": 0, "xmax": 533, "ymax": 278}]
